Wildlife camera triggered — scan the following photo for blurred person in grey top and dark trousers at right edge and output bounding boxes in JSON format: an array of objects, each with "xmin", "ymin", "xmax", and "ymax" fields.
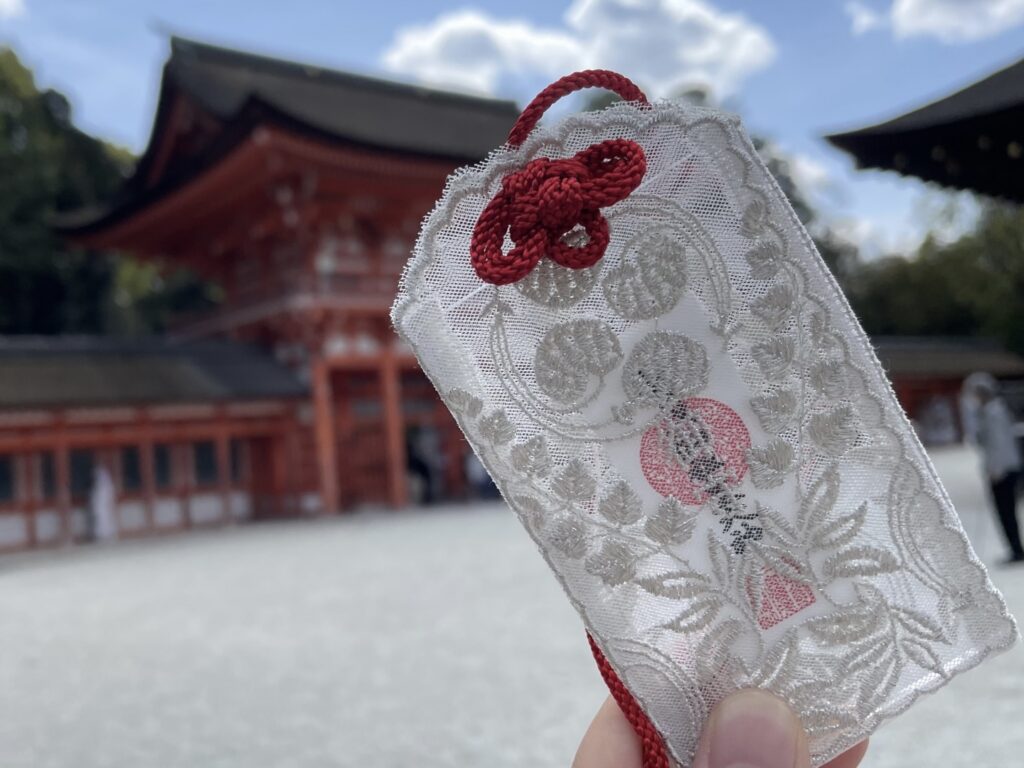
[{"xmin": 964, "ymin": 373, "xmax": 1024, "ymax": 563}]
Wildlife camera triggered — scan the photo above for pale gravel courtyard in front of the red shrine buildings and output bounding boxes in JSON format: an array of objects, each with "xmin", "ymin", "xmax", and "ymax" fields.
[{"xmin": 0, "ymin": 450, "xmax": 1024, "ymax": 768}]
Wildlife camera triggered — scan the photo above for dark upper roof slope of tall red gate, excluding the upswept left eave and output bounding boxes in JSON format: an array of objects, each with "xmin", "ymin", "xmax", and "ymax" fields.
[{"xmin": 165, "ymin": 38, "xmax": 519, "ymax": 160}]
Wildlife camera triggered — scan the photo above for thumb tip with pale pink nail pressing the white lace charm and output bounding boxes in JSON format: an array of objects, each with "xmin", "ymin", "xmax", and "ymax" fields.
[{"xmin": 693, "ymin": 690, "xmax": 806, "ymax": 768}]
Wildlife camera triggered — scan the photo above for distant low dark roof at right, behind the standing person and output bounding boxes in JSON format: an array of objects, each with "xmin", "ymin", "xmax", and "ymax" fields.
[{"xmin": 871, "ymin": 336, "xmax": 1024, "ymax": 379}]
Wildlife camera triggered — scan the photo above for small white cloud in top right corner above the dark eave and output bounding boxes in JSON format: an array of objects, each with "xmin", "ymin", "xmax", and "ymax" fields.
[{"xmin": 890, "ymin": 0, "xmax": 1024, "ymax": 43}]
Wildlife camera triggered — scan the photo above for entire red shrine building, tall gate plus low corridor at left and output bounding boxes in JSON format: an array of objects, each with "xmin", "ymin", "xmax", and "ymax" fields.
[{"xmin": 0, "ymin": 38, "xmax": 518, "ymax": 549}]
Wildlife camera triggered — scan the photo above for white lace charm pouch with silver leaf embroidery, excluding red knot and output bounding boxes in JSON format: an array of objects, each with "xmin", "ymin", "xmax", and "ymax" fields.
[{"xmin": 392, "ymin": 103, "xmax": 1017, "ymax": 765}]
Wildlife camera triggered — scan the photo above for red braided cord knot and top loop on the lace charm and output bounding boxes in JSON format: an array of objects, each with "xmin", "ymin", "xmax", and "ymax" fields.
[{"xmin": 469, "ymin": 70, "xmax": 647, "ymax": 286}]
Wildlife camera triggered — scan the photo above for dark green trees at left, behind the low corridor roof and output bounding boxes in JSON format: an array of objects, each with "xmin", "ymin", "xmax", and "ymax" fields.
[{"xmin": 0, "ymin": 48, "xmax": 216, "ymax": 334}]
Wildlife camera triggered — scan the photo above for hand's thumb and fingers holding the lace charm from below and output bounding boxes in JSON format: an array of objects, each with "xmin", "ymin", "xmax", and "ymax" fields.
[{"xmin": 572, "ymin": 690, "xmax": 867, "ymax": 768}]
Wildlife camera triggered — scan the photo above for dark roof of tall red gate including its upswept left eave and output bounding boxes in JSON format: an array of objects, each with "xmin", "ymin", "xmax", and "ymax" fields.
[{"xmin": 54, "ymin": 38, "xmax": 519, "ymax": 237}]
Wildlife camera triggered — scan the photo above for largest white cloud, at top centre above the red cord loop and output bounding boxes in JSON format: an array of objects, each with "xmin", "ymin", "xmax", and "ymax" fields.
[{"xmin": 382, "ymin": 0, "xmax": 775, "ymax": 98}]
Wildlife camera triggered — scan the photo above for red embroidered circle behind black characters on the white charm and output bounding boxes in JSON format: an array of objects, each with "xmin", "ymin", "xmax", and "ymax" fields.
[{"xmin": 640, "ymin": 397, "xmax": 751, "ymax": 504}]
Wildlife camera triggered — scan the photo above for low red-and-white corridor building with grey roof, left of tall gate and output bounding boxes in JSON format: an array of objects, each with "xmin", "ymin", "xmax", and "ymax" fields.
[{"xmin": 0, "ymin": 336, "xmax": 308, "ymax": 549}]
